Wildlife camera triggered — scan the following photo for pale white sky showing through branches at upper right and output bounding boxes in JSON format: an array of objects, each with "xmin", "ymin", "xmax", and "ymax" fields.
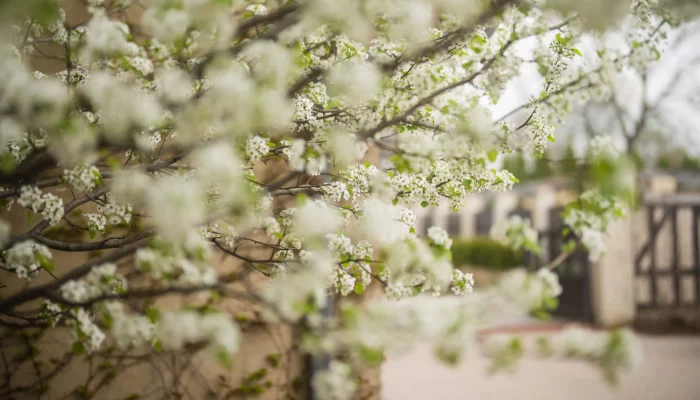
[{"xmin": 492, "ymin": 16, "xmax": 700, "ymax": 156}]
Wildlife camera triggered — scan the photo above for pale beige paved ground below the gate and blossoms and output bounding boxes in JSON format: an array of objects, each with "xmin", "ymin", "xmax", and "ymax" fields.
[{"xmin": 382, "ymin": 336, "xmax": 700, "ymax": 400}]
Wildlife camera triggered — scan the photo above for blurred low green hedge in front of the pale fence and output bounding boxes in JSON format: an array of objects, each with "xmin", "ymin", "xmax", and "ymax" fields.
[{"xmin": 452, "ymin": 236, "xmax": 524, "ymax": 270}]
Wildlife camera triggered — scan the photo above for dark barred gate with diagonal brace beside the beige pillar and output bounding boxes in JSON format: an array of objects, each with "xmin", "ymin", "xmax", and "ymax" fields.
[{"xmin": 634, "ymin": 202, "xmax": 700, "ymax": 310}]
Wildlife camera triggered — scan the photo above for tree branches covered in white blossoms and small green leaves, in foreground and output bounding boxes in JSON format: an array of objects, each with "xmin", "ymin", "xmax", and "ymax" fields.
[{"xmin": 0, "ymin": 0, "xmax": 694, "ymax": 399}]
